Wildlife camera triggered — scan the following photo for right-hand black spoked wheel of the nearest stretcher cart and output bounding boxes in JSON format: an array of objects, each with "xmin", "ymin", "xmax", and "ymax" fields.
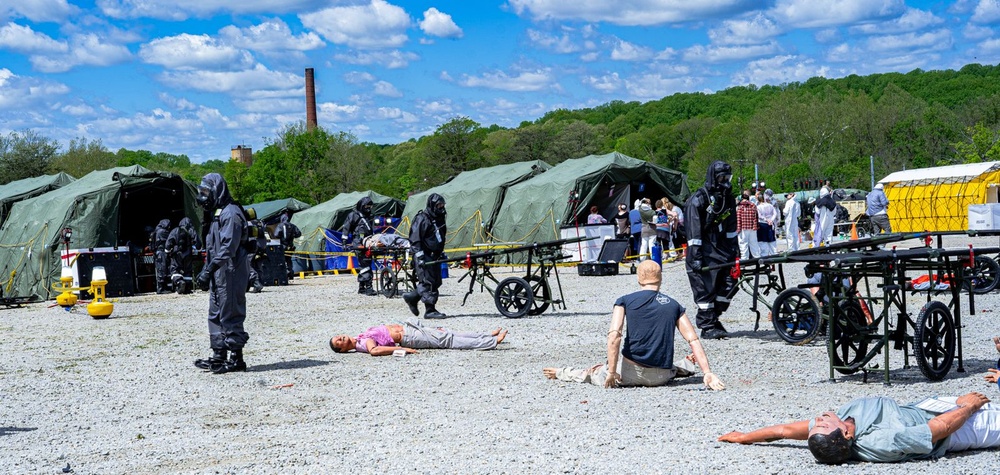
[{"xmin": 913, "ymin": 300, "xmax": 955, "ymax": 381}]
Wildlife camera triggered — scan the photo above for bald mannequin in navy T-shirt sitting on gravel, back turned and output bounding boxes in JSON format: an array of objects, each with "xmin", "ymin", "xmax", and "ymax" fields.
[{"xmin": 542, "ymin": 259, "xmax": 726, "ymax": 390}]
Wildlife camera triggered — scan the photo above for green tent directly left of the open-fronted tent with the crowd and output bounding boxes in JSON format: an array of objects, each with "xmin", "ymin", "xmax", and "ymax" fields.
[{"xmin": 403, "ymin": 160, "xmax": 552, "ymax": 249}]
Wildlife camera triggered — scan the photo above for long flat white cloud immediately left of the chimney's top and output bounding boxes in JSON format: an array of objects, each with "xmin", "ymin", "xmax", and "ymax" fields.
[{"xmin": 160, "ymin": 64, "xmax": 305, "ymax": 97}]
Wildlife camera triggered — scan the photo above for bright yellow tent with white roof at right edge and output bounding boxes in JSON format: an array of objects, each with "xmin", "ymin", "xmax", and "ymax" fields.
[{"xmin": 879, "ymin": 162, "xmax": 1000, "ymax": 232}]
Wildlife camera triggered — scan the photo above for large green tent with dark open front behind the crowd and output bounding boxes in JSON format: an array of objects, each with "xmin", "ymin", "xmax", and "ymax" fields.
[{"xmin": 493, "ymin": 152, "xmax": 690, "ymax": 242}]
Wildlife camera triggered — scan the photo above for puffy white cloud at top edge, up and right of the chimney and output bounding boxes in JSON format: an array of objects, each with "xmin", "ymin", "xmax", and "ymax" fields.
[{"xmin": 299, "ymin": 0, "xmax": 410, "ymax": 49}]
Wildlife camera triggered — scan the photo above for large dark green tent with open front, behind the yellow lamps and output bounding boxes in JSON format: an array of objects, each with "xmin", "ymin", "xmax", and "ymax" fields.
[{"xmin": 0, "ymin": 165, "xmax": 202, "ymax": 299}]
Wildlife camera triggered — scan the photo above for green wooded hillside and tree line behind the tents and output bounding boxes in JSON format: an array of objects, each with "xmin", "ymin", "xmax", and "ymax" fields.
[{"xmin": 0, "ymin": 64, "xmax": 1000, "ymax": 203}]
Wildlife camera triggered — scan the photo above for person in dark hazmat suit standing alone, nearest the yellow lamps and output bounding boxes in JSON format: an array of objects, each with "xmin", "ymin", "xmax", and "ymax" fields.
[{"xmin": 194, "ymin": 173, "xmax": 250, "ymax": 374}]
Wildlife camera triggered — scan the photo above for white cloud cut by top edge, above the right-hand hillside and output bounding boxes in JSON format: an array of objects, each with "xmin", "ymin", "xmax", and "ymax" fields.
[{"xmin": 770, "ymin": 0, "xmax": 905, "ymax": 28}]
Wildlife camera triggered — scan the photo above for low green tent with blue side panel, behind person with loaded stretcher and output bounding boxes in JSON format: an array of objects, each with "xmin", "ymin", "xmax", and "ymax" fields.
[{"xmin": 292, "ymin": 190, "xmax": 403, "ymax": 255}]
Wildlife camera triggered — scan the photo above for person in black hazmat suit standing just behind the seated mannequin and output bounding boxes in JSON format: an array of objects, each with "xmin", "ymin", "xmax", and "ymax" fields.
[{"xmin": 684, "ymin": 160, "xmax": 738, "ymax": 339}]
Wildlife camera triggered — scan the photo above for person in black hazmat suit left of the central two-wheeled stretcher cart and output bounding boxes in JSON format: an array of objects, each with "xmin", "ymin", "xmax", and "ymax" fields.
[{"xmin": 403, "ymin": 193, "xmax": 448, "ymax": 318}]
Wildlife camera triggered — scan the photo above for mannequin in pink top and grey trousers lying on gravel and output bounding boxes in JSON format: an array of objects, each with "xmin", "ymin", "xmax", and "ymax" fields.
[{"xmin": 330, "ymin": 318, "xmax": 507, "ymax": 356}]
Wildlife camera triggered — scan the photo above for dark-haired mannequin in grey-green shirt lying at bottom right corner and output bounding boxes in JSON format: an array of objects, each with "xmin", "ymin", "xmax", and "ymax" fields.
[{"xmin": 719, "ymin": 392, "xmax": 1000, "ymax": 464}]
